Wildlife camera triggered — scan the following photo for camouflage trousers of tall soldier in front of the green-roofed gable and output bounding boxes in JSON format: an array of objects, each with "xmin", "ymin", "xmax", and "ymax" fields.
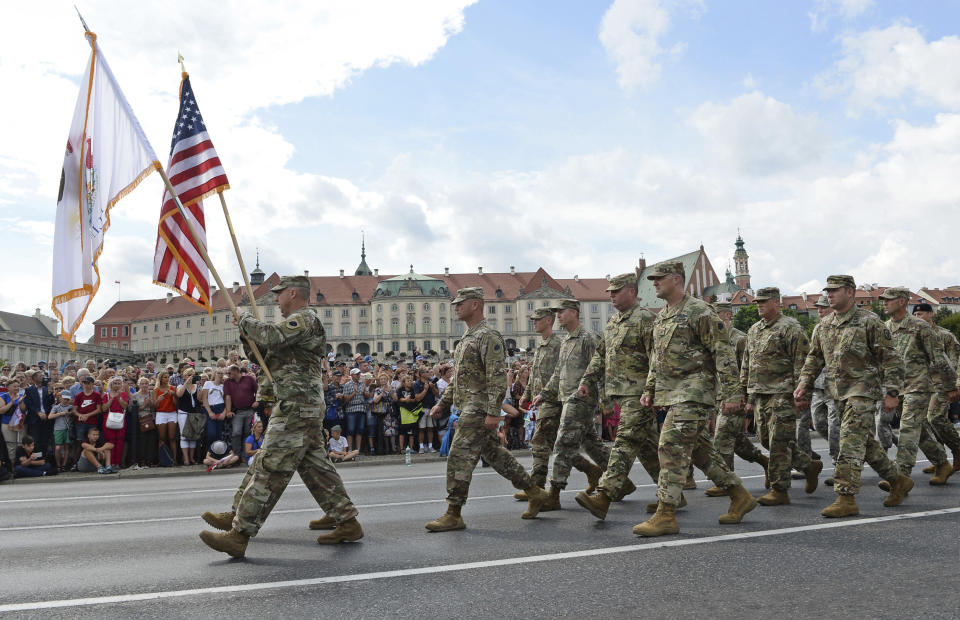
[{"xmin": 657, "ymin": 402, "xmax": 741, "ymax": 506}]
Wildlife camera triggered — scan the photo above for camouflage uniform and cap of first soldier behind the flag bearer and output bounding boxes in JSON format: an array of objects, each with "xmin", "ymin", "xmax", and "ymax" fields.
[{"xmin": 438, "ymin": 308, "xmax": 533, "ymax": 506}]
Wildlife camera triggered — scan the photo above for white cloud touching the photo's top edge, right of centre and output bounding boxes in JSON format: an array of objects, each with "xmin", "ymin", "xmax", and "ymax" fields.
[{"xmin": 600, "ymin": 0, "xmax": 703, "ymax": 92}]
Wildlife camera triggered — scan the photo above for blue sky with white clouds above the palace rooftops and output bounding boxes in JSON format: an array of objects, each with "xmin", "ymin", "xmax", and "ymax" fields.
[{"xmin": 0, "ymin": 0, "xmax": 960, "ymax": 336}]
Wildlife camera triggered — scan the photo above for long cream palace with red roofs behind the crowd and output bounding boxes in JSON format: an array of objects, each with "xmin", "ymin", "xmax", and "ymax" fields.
[{"xmin": 94, "ymin": 241, "xmax": 732, "ymax": 363}]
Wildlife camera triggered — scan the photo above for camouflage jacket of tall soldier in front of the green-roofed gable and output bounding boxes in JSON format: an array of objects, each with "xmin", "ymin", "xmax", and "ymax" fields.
[{"xmin": 644, "ymin": 295, "xmax": 740, "ymax": 407}]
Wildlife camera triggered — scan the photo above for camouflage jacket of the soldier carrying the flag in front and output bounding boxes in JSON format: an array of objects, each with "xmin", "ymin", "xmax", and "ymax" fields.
[{"xmin": 237, "ymin": 308, "xmax": 327, "ymax": 417}]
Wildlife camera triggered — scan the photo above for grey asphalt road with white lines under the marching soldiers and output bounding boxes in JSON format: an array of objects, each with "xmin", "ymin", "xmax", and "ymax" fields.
[{"xmin": 0, "ymin": 441, "xmax": 960, "ymax": 619}]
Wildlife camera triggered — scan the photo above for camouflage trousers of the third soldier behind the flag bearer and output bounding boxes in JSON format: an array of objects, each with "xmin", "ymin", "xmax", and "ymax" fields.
[{"xmin": 550, "ymin": 395, "xmax": 610, "ymax": 489}]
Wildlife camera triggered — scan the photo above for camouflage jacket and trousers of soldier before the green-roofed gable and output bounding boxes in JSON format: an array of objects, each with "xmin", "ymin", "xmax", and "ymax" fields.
[{"xmin": 644, "ymin": 294, "xmax": 741, "ymax": 507}]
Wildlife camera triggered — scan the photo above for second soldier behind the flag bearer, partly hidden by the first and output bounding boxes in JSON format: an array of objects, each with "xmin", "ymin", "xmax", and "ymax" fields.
[{"xmin": 514, "ymin": 308, "xmax": 560, "ymax": 501}]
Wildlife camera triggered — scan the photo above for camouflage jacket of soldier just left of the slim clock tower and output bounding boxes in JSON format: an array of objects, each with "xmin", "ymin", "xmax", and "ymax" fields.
[{"xmin": 740, "ymin": 314, "xmax": 810, "ymax": 394}]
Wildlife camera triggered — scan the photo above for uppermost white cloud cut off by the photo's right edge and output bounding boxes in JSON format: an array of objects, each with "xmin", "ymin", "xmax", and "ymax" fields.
[{"xmin": 816, "ymin": 24, "xmax": 960, "ymax": 115}]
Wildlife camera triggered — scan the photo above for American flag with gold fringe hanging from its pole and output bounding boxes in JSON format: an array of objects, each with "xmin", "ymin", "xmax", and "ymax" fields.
[{"xmin": 153, "ymin": 73, "xmax": 230, "ymax": 310}]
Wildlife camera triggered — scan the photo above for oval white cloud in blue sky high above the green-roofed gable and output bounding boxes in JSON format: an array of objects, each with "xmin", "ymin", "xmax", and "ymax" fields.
[{"xmin": 688, "ymin": 91, "xmax": 825, "ymax": 175}]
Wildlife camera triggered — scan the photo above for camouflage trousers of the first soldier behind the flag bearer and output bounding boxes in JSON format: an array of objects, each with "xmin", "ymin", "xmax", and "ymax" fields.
[{"xmin": 447, "ymin": 413, "xmax": 533, "ymax": 506}]
